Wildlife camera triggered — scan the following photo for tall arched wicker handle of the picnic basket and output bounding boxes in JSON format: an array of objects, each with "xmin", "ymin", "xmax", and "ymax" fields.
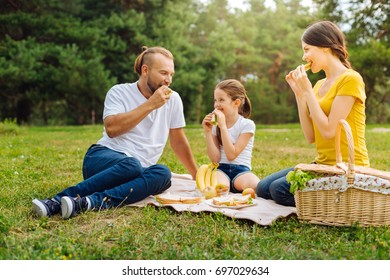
[{"xmin": 335, "ymin": 119, "xmax": 355, "ymax": 186}]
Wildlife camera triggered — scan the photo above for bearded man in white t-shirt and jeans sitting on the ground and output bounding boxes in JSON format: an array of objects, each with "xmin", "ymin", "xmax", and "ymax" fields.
[{"xmin": 32, "ymin": 47, "xmax": 197, "ymax": 219}]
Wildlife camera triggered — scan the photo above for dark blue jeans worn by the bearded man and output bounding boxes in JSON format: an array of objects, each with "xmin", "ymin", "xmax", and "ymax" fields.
[{"xmin": 54, "ymin": 145, "xmax": 172, "ymax": 209}]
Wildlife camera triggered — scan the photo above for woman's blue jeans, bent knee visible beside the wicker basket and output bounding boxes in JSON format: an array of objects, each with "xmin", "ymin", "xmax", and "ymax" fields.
[{"xmin": 256, "ymin": 168, "xmax": 295, "ymax": 206}]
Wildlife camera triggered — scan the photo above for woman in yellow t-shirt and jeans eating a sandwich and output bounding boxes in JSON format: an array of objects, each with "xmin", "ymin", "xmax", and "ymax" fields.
[{"xmin": 256, "ymin": 21, "xmax": 369, "ymax": 206}]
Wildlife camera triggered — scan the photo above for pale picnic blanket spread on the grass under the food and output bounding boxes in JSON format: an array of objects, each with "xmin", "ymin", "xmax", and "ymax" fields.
[{"xmin": 129, "ymin": 173, "xmax": 297, "ymax": 226}]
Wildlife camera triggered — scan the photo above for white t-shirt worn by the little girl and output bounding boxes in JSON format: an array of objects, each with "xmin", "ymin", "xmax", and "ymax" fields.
[{"xmin": 212, "ymin": 115, "xmax": 256, "ymax": 169}]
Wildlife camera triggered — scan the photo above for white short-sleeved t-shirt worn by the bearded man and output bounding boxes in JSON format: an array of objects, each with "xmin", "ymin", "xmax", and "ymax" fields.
[{"xmin": 97, "ymin": 82, "xmax": 185, "ymax": 167}]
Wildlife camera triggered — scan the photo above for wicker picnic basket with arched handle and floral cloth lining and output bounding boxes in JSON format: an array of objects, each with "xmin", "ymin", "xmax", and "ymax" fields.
[{"xmin": 294, "ymin": 120, "xmax": 390, "ymax": 226}]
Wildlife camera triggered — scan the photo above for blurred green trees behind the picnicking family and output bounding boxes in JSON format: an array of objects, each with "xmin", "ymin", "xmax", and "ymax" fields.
[{"xmin": 0, "ymin": 0, "xmax": 390, "ymax": 125}]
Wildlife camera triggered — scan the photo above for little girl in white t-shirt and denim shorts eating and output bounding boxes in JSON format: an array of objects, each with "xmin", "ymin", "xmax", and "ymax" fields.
[{"xmin": 202, "ymin": 79, "xmax": 260, "ymax": 193}]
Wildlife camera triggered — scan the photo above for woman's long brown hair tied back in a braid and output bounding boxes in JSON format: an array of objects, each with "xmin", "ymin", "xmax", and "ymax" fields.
[{"xmin": 302, "ymin": 21, "xmax": 352, "ymax": 69}]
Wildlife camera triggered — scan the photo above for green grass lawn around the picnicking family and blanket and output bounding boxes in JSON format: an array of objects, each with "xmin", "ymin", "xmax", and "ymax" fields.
[{"xmin": 0, "ymin": 124, "xmax": 390, "ymax": 260}]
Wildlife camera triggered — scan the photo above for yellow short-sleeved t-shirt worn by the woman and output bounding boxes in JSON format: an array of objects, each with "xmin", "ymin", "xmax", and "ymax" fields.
[{"xmin": 313, "ymin": 69, "xmax": 370, "ymax": 166}]
